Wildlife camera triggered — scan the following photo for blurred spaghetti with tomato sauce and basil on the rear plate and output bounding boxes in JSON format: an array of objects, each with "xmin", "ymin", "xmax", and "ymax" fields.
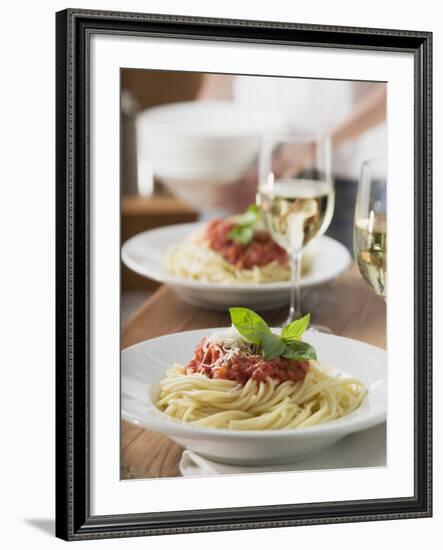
[{"xmin": 164, "ymin": 210, "xmax": 308, "ymax": 284}]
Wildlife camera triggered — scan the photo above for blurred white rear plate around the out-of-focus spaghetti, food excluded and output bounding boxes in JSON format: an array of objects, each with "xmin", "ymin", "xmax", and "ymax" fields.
[{"xmin": 122, "ymin": 223, "xmax": 351, "ymax": 311}]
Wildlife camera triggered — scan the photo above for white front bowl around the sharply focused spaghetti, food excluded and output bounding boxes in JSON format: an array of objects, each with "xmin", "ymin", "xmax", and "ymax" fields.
[{"xmin": 122, "ymin": 329, "xmax": 386, "ymax": 466}]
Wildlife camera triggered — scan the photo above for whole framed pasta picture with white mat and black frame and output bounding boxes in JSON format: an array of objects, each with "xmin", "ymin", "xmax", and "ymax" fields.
[{"xmin": 56, "ymin": 9, "xmax": 432, "ymax": 540}]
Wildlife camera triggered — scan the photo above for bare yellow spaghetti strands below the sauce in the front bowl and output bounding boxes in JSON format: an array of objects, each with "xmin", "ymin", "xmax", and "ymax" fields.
[{"xmin": 156, "ymin": 361, "xmax": 367, "ymax": 430}]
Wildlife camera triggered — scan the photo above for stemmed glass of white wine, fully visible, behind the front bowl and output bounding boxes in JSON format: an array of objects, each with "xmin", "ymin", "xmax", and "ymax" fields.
[{"xmin": 257, "ymin": 134, "xmax": 335, "ymax": 324}]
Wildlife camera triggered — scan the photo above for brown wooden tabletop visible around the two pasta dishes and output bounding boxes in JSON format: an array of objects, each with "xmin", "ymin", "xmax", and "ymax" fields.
[{"xmin": 121, "ymin": 266, "xmax": 386, "ymax": 479}]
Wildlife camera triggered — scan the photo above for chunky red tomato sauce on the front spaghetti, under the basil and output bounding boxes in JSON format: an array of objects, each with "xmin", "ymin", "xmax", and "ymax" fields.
[{"xmin": 186, "ymin": 338, "xmax": 309, "ymax": 385}]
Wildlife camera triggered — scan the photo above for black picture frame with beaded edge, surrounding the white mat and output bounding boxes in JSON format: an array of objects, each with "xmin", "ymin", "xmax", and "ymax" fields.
[{"xmin": 56, "ymin": 9, "xmax": 432, "ymax": 540}]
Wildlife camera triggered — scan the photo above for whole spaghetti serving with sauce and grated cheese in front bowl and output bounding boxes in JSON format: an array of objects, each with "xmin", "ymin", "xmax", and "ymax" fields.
[{"xmin": 156, "ymin": 308, "xmax": 366, "ymax": 430}]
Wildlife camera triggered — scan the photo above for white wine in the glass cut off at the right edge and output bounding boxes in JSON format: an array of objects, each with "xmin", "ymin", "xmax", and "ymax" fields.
[{"xmin": 354, "ymin": 212, "xmax": 386, "ymax": 298}]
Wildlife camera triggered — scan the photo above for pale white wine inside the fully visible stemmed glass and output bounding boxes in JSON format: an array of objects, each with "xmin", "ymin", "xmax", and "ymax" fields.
[{"xmin": 260, "ymin": 179, "xmax": 335, "ymax": 252}]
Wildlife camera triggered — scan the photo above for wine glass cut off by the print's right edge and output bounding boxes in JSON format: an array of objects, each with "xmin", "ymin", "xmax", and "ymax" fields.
[{"xmin": 354, "ymin": 159, "xmax": 386, "ymax": 300}]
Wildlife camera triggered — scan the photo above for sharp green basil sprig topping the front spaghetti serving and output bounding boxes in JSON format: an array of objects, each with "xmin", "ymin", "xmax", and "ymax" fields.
[{"xmin": 229, "ymin": 307, "xmax": 317, "ymax": 360}]
